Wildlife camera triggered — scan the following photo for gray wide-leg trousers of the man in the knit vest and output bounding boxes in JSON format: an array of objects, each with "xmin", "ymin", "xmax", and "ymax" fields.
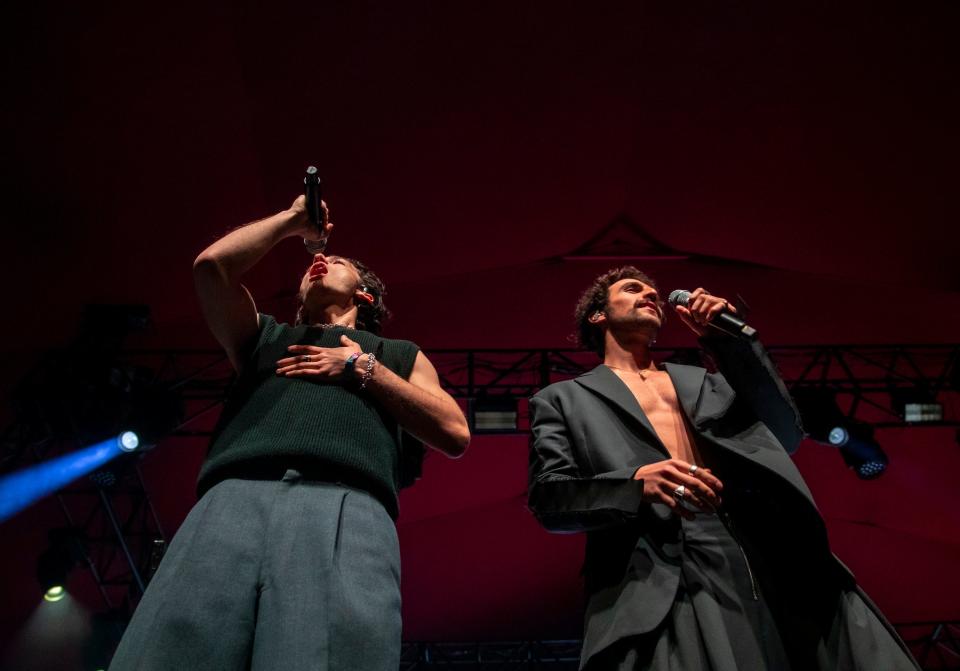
[{"xmin": 110, "ymin": 470, "xmax": 401, "ymax": 671}]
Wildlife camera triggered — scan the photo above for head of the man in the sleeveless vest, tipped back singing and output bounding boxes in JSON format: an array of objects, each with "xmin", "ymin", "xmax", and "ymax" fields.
[{"xmin": 296, "ymin": 254, "xmax": 390, "ymax": 334}]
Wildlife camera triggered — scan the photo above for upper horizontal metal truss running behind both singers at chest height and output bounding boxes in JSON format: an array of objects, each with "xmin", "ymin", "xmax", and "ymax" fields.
[{"xmin": 97, "ymin": 344, "xmax": 960, "ymax": 435}]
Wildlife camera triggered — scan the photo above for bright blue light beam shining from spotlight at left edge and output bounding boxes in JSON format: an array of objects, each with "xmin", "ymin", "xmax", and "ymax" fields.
[{"xmin": 0, "ymin": 431, "xmax": 140, "ymax": 522}]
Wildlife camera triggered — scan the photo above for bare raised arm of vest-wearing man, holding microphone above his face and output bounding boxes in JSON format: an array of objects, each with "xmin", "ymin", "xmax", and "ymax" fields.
[{"xmin": 193, "ymin": 196, "xmax": 332, "ymax": 370}]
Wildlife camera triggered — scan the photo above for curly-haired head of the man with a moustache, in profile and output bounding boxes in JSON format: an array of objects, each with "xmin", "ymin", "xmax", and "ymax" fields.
[{"xmin": 574, "ymin": 266, "xmax": 665, "ymax": 357}]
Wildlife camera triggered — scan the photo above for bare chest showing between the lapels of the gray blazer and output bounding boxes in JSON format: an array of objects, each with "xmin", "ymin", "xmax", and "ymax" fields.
[{"xmin": 610, "ymin": 366, "xmax": 703, "ymax": 466}]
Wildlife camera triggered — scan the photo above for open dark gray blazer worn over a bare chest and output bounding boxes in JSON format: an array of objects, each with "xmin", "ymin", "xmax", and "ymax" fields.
[{"xmin": 529, "ymin": 336, "xmax": 852, "ymax": 667}]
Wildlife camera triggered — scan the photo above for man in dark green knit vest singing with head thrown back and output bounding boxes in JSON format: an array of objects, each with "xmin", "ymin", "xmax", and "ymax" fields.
[{"xmin": 110, "ymin": 196, "xmax": 470, "ymax": 671}]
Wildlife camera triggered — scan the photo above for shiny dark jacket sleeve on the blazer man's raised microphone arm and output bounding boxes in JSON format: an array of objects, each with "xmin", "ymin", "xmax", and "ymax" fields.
[{"xmin": 700, "ymin": 335, "xmax": 805, "ymax": 454}]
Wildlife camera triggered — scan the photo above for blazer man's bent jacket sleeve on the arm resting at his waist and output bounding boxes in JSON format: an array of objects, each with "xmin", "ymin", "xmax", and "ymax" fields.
[{"xmin": 528, "ymin": 396, "xmax": 643, "ymax": 533}]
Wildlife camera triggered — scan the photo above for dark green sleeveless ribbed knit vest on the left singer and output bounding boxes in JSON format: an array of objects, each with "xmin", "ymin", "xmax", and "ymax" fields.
[{"xmin": 197, "ymin": 314, "xmax": 419, "ymax": 518}]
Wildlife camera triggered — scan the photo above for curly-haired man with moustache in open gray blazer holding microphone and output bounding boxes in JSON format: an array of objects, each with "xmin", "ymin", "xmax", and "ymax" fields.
[{"xmin": 529, "ymin": 266, "xmax": 918, "ymax": 671}]
